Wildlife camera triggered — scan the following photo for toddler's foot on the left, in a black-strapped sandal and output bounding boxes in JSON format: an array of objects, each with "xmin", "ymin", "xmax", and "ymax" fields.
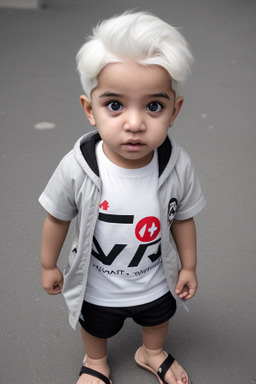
[{"xmin": 77, "ymin": 355, "xmax": 111, "ymax": 384}]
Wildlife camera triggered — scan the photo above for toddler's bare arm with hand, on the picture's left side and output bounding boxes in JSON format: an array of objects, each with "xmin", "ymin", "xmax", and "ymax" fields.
[{"xmin": 41, "ymin": 213, "xmax": 70, "ymax": 295}]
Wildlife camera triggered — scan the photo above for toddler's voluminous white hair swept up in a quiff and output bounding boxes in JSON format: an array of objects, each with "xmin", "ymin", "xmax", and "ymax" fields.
[{"xmin": 76, "ymin": 12, "xmax": 193, "ymax": 98}]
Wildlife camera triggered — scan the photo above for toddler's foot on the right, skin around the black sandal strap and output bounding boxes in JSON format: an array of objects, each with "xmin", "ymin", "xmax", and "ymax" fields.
[{"xmin": 137, "ymin": 345, "xmax": 190, "ymax": 384}]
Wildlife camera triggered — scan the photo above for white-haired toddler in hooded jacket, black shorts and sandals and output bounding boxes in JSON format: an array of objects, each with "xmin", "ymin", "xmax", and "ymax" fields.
[{"xmin": 39, "ymin": 12, "xmax": 205, "ymax": 384}]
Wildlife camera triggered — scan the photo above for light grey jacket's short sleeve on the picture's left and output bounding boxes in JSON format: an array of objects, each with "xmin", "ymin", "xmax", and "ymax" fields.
[{"xmin": 39, "ymin": 152, "xmax": 78, "ymax": 221}]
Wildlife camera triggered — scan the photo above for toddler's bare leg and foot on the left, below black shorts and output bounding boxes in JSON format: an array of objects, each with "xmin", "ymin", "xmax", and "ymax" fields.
[{"xmin": 77, "ymin": 328, "xmax": 110, "ymax": 384}]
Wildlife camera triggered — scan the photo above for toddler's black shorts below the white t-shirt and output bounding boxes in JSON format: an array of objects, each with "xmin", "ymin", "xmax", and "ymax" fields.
[{"xmin": 79, "ymin": 292, "xmax": 176, "ymax": 338}]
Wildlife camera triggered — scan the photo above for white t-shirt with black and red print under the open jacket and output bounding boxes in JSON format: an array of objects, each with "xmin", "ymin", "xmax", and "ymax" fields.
[{"xmin": 85, "ymin": 141, "xmax": 169, "ymax": 307}]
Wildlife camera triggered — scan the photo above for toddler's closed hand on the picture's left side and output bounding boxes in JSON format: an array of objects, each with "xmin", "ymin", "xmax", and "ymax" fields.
[{"xmin": 41, "ymin": 267, "xmax": 63, "ymax": 295}]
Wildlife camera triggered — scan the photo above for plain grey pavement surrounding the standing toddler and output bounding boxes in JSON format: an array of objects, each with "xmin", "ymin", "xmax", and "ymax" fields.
[{"xmin": 0, "ymin": 0, "xmax": 256, "ymax": 384}]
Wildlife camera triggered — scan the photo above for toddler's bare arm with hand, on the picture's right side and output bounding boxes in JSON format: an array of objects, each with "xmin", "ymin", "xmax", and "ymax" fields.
[{"xmin": 171, "ymin": 218, "xmax": 197, "ymax": 300}]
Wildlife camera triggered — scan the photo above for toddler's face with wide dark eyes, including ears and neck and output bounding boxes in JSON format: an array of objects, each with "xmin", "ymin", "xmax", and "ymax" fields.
[{"xmin": 81, "ymin": 62, "xmax": 183, "ymax": 169}]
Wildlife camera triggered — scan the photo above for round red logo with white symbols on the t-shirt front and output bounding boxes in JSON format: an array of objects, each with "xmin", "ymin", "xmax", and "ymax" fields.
[{"xmin": 135, "ymin": 216, "xmax": 160, "ymax": 243}]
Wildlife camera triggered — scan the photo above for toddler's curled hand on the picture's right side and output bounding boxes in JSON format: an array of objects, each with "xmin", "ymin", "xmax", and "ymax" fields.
[{"xmin": 175, "ymin": 268, "xmax": 198, "ymax": 300}]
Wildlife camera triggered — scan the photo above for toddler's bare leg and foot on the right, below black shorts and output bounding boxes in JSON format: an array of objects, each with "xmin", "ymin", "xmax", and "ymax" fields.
[{"xmin": 138, "ymin": 322, "xmax": 189, "ymax": 384}]
